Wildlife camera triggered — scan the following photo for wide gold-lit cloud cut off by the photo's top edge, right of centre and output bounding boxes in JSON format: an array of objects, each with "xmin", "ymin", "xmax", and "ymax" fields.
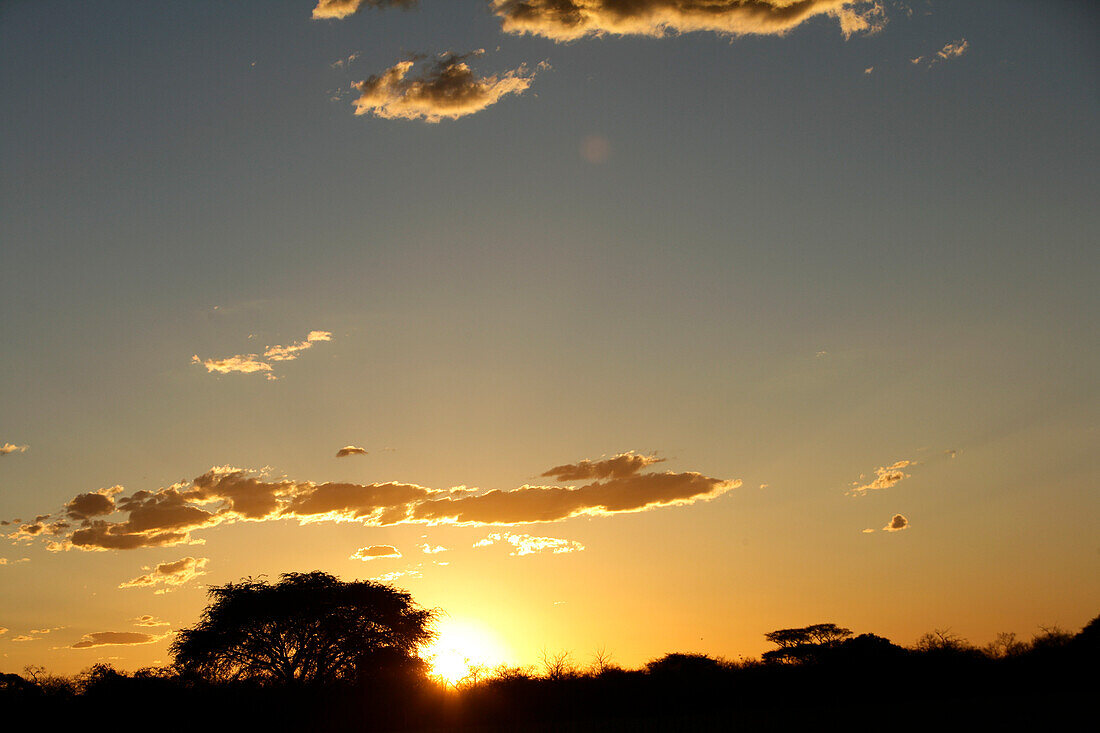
[{"xmin": 491, "ymin": 0, "xmax": 886, "ymax": 42}]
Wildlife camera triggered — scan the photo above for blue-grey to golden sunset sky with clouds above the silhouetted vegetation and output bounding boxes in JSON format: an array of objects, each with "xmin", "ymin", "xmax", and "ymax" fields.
[{"xmin": 0, "ymin": 0, "xmax": 1100, "ymax": 674}]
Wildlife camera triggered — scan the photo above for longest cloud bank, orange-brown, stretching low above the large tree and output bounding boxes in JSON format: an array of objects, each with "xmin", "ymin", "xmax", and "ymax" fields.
[{"xmin": 9, "ymin": 453, "xmax": 741, "ymax": 548}]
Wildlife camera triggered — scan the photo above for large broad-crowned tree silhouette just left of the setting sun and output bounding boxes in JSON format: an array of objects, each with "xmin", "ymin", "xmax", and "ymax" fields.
[{"xmin": 171, "ymin": 571, "xmax": 435, "ymax": 685}]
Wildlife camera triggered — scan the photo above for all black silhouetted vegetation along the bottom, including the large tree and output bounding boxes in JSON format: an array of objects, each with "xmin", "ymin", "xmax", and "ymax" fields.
[{"xmin": 0, "ymin": 573, "xmax": 1100, "ymax": 732}]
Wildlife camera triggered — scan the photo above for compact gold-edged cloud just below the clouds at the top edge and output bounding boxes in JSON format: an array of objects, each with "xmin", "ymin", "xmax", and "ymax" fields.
[{"xmin": 352, "ymin": 51, "xmax": 535, "ymax": 122}]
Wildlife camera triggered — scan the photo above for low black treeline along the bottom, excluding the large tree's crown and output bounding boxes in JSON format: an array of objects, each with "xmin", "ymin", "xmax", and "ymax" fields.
[{"xmin": 0, "ymin": 616, "xmax": 1100, "ymax": 732}]
